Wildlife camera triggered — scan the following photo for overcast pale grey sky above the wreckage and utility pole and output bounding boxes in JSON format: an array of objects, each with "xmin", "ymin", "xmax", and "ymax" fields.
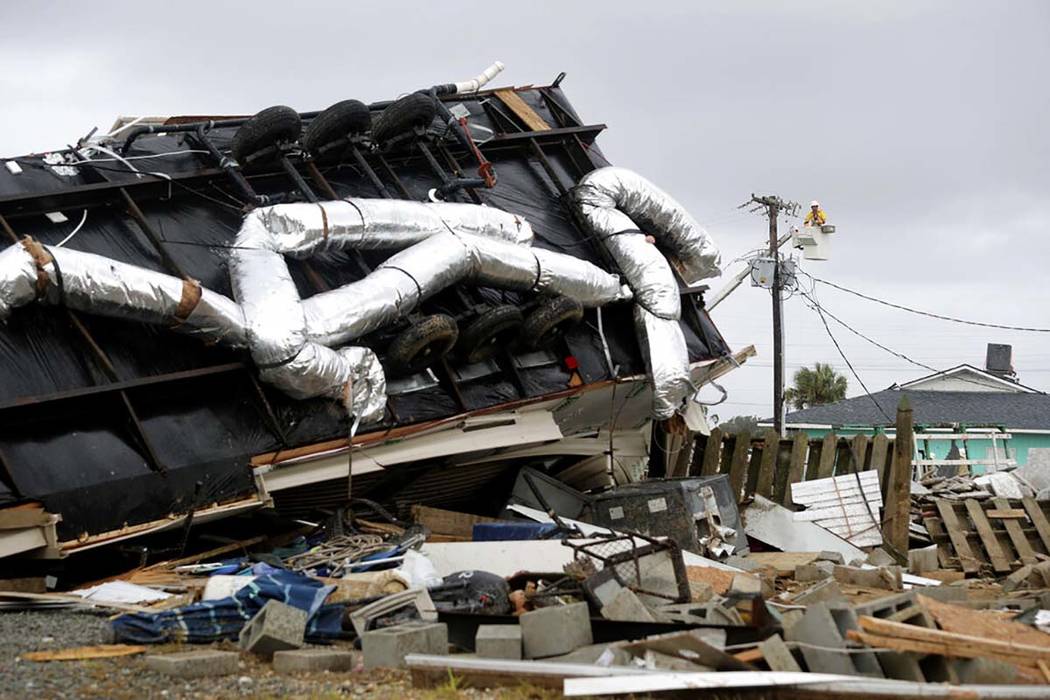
[{"xmin": 0, "ymin": 0, "xmax": 1050, "ymax": 419}]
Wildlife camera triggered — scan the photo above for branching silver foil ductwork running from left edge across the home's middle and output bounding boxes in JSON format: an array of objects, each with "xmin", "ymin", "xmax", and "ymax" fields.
[{"xmin": 0, "ymin": 199, "xmax": 631, "ymax": 422}]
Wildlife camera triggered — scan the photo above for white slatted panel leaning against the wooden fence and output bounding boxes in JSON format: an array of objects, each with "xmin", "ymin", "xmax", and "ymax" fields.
[{"xmin": 791, "ymin": 469, "xmax": 882, "ymax": 547}]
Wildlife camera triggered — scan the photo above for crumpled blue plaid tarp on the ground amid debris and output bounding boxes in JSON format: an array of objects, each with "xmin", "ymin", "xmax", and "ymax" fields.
[{"xmin": 111, "ymin": 570, "xmax": 348, "ymax": 644}]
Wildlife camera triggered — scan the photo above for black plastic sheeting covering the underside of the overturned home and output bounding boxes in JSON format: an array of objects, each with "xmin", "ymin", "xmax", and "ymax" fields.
[{"xmin": 0, "ymin": 88, "xmax": 728, "ymax": 538}]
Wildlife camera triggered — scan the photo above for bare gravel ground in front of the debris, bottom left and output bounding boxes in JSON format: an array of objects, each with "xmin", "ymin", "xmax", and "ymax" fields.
[{"xmin": 0, "ymin": 610, "xmax": 555, "ymax": 700}]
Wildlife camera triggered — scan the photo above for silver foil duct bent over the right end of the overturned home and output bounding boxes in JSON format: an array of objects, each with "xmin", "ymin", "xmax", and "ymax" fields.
[{"xmin": 572, "ymin": 168, "xmax": 720, "ymax": 419}]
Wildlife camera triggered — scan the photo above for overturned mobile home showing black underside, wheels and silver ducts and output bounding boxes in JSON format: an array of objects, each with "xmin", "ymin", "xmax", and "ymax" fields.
[{"xmin": 0, "ymin": 67, "xmax": 747, "ymax": 556}]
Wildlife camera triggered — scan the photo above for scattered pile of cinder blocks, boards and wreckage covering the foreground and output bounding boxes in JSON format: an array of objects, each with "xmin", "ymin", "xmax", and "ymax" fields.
[{"xmin": 0, "ymin": 457, "xmax": 1050, "ymax": 697}]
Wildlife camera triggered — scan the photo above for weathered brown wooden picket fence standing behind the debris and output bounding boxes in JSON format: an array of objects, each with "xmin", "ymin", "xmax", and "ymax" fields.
[{"xmin": 689, "ymin": 428, "xmax": 894, "ymax": 507}]
